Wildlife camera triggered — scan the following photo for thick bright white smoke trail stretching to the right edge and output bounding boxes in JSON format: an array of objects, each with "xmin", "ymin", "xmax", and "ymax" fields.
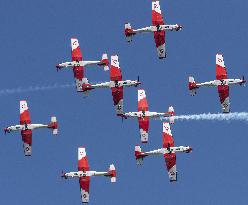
[{"xmin": 161, "ymin": 112, "xmax": 248, "ymax": 122}]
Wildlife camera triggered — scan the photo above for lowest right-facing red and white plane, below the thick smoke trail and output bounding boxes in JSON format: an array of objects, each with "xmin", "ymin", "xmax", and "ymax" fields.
[{"xmin": 135, "ymin": 122, "xmax": 192, "ymax": 182}]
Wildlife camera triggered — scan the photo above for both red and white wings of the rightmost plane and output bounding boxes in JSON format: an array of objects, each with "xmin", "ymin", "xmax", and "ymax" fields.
[{"xmin": 216, "ymin": 54, "xmax": 230, "ymax": 113}]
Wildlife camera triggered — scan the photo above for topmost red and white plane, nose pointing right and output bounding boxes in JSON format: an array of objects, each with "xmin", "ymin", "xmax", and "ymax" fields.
[{"xmin": 125, "ymin": 0, "xmax": 183, "ymax": 59}]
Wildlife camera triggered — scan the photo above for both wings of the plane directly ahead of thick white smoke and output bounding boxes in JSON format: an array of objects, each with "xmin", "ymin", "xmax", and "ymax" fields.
[{"xmin": 138, "ymin": 89, "xmax": 149, "ymax": 143}]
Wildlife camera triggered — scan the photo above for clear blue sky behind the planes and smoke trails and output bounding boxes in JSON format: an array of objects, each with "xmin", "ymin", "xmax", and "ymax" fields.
[{"xmin": 0, "ymin": 0, "xmax": 248, "ymax": 205}]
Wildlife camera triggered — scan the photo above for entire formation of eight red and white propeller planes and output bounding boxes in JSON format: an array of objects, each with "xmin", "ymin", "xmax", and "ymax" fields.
[{"xmin": 1, "ymin": 0, "xmax": 246, "ymax": 203}]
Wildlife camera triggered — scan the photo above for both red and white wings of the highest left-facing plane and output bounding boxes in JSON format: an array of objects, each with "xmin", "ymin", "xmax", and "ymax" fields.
[{"xmin": 71, "ymin": 38, "xmax": 84, "ymax": 91}]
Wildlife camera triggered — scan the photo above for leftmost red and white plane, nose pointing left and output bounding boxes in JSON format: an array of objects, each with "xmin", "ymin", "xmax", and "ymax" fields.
[{"xmin": 4, "ymin": 100, "xmax": 58, "ymax": 156}]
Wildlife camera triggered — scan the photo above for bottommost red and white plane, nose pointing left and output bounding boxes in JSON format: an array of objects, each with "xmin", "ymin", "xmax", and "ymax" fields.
[{"xmin": 61, "ymin": 147, "xmax": 116, "ymax": 203}]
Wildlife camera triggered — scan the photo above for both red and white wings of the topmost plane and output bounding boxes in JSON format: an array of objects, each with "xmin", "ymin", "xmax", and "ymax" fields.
[{"xmin": 152, "ymin": 0, "xmax": 166, "ymax": 58}]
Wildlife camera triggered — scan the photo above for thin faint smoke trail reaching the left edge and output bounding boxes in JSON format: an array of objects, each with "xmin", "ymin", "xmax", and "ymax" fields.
[{"xmin": 0, "ymin": 83, "xmax": 75, "ymax": 96}]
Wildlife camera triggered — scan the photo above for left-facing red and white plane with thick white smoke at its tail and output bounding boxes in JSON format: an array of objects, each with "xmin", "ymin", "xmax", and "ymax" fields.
[{"xmin": 119, "ymin": 89, "xmax": 175, "ymax": 143}]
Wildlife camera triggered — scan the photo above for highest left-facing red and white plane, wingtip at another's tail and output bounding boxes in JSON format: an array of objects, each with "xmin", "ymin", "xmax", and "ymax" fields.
[{"xmin": 56, "ymin": 38, "xmax": 109, "ymax": 92}]
